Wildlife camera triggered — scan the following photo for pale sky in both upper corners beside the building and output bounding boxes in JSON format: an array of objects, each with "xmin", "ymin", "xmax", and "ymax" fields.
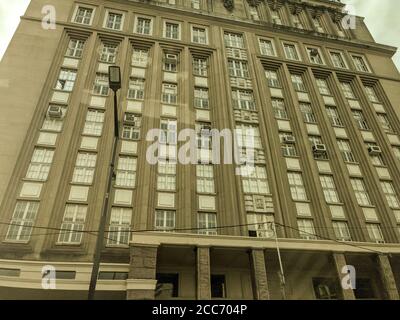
[{"xmin": 0, "ymin": 0, "xmax": 400, "ymax": 69}]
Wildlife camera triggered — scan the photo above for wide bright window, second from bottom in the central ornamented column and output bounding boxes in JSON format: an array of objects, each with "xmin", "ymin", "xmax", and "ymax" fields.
[{"xmin": 240, "ymin": 166, "xmax": 270, "ymax": 194}]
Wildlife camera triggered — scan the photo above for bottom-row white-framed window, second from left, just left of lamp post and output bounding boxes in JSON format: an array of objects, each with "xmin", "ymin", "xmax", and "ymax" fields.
[{"xmin": 58, "ymin": 204, "xmax": 87, "ymax": 244}]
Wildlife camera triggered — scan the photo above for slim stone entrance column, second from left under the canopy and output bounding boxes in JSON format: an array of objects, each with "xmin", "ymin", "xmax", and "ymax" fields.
[{"xmin": 196, "ymin": 247, "xmax": 211, "ymax": 300}]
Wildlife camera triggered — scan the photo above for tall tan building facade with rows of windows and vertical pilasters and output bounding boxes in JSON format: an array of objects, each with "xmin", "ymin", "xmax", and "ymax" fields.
[{"xmin": 0, "ymin": 0, "xmax": 400, "ymax": 299}]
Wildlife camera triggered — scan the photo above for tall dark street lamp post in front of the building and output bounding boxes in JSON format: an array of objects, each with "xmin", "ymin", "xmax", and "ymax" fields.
[{"xmin": 88, "ymin": 66, "xmax": 121, "ymax": 300}]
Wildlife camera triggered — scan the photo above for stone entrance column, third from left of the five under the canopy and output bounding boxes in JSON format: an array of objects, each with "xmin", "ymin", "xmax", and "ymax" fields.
[{"xmin": 250, "ymin": 249, "xmax": 269, "ymax": 300}]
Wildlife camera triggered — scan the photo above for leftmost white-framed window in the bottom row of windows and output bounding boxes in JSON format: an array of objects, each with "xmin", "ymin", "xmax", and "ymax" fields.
[{"xmin": 6, "ymin": 201, "xmax": 39, "ymax": 242}]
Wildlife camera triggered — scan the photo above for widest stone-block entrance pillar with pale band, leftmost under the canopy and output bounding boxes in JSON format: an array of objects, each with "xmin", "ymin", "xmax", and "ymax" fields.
[{"xmin": 127, "ymin": 246, "xmax": 157, "ymax": 300}]
